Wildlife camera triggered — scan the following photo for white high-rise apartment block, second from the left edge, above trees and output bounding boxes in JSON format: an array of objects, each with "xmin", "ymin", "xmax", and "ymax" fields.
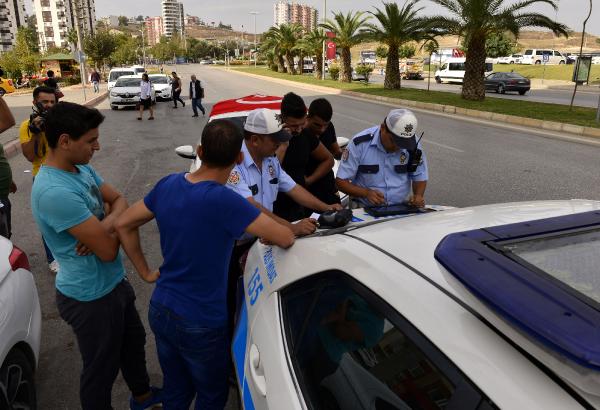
[{"xmin": 33, "ymin": 0, "xmax": 96, "ymax": 51}]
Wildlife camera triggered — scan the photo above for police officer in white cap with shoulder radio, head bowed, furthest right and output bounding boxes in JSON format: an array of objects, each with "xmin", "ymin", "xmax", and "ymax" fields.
[{"xmin": 336, "ymin": 109, "xmax": 428, "ymax": 207}]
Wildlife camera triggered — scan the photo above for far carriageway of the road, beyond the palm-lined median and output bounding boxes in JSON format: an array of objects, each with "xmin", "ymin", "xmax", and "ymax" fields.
[{"xmin": 370, "ymin": 73, "xmax": 600, "ymax": 108}]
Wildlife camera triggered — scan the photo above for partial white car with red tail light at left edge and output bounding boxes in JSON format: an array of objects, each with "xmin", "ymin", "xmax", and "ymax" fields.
[{"xmin": 0, "ymin": 237, "xmax": 43, "ymax": 409}]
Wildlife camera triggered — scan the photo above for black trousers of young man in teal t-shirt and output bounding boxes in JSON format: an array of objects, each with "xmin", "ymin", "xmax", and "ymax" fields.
[{"xmin": 56, "ymin": 279, "xmax": 150, "ymax": 410}]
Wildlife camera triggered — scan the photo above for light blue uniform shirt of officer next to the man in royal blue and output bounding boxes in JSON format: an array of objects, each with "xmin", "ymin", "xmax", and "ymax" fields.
[{"xmin": 227, "ymin": 141, "xmax": 296, "ymax": 212}]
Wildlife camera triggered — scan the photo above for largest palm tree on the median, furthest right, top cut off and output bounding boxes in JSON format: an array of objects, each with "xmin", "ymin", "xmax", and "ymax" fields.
[{"xmin": 429, "ymin": 0, "xmax": 568, "ymax": 101}]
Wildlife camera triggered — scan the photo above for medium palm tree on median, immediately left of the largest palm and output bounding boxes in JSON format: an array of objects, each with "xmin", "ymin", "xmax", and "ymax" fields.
[{"xmin": 367, "ymin": 0, "xmax": 431, "ymax": 89}]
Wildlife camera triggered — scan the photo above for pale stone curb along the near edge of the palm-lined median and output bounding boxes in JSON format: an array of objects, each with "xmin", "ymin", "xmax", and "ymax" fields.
[{"xmin": 228, "ymin": 70, "xmax": 600, "ymax": 138}]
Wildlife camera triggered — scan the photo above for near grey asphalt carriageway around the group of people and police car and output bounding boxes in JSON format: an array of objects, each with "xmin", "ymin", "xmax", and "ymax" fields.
[{"xmin": 4, "ymin": 65, "xmax": 600, "ymax": 410}]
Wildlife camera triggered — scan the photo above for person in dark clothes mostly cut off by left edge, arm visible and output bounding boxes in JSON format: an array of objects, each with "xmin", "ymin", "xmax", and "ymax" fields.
[{"xmin": 0, "ymin": 97, "xmax": 17, "ymax": 239}]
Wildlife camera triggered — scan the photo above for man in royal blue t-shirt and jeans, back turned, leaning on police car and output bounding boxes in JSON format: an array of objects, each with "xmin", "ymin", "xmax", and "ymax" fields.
[{"xmin": 117, "ymin": 120, "xmax": 294, "ymax": 409}]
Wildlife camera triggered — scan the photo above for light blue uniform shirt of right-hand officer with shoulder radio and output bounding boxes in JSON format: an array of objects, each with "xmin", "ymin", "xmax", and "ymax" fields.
[{"xmin": 337, "ymin": 125, "xmax": 429, "ymax": 205}]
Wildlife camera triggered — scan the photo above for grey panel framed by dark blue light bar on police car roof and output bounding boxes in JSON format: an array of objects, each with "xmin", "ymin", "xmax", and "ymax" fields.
[{"xmin": 504, "ymin": 228, "xmax": 600, "ymax": 303}]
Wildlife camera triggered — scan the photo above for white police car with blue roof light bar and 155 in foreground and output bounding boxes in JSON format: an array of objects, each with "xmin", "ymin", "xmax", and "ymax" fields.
[{"xmin": 232, "ymin": 200, "xmax": 600, "ymax": 410}]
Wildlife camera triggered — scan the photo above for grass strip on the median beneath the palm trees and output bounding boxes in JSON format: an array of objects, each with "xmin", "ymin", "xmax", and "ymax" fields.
[{"xmin": 232, "ymin": 67, "xmax": 600, "ymax": 128}]
